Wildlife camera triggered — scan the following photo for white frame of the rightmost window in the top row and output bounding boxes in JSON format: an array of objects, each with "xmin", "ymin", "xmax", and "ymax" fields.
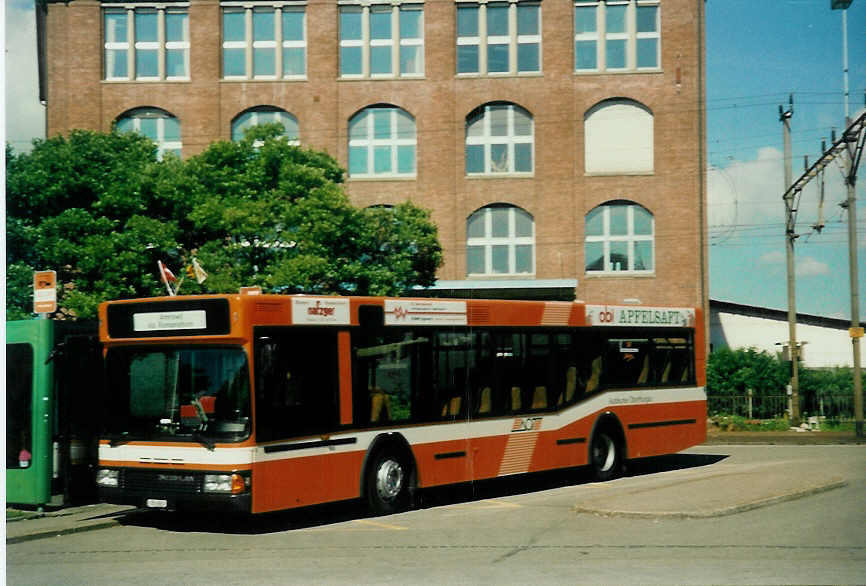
[{"xmin": 572, "ymin": 0, "xmax": 662, "ymax": 73}]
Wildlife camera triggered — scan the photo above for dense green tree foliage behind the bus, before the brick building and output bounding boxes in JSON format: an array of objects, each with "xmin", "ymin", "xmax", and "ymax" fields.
[{"xmin": 6, "ymin": 125, "xmax": 442, "ymax": 319}]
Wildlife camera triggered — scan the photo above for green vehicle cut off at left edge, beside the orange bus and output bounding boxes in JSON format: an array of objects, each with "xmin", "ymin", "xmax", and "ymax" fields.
[{"xmin": 6, "ymin": 319, "xmax": 103, "ymax": 508}]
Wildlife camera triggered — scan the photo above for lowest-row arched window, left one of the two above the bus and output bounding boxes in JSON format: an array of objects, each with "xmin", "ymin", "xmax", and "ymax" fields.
[{"xmin": 466, "ymin": 204, "xmax": 535, "ymax": 275}]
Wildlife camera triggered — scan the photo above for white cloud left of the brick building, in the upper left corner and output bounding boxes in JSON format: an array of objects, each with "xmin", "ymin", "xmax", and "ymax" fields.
[{"xmin": 4, "ymin": 0, "xmax": 45, "ymax": 152}]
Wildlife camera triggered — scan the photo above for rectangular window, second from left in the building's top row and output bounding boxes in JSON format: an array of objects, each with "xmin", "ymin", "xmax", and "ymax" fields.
[{"xmin": 222, "ymin": 2, "xmax": 307, "ymax": 79}]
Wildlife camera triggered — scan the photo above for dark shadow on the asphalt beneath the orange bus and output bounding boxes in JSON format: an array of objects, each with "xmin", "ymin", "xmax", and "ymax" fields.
[{"xmin": 118, "ymin": 454, "xmax": 729, "ymax": 535}]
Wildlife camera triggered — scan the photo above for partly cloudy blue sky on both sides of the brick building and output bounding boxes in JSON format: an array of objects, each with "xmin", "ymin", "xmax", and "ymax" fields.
[{"xmin": 3, "ymin": 0, "xmax": 866, "ymax": 320}]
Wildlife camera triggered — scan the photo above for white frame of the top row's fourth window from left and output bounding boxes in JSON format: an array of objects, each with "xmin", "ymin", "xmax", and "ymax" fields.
[{"xmin": 455, "ymin": 0, "xmax": 543, "ymax": 77}]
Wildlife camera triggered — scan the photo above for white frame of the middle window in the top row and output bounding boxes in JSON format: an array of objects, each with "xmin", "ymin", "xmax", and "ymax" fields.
[{"xmin": 337, "ymin": 0, "xmax": 425, "ymax": 80}]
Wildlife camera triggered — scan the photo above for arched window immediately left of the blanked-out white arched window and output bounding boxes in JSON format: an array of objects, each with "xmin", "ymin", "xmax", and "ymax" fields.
[{"xmin": 466, "ymin": 102, "xmax": 534, "ymax": 175}]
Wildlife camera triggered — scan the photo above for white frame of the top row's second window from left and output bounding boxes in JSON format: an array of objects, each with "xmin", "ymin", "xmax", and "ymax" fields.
[{"xmin": 220, "ymin": 0, "xmax": 307, "ymax": 81}]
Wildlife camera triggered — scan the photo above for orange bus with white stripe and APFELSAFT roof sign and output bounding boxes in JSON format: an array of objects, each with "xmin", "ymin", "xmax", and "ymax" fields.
[{"xmin": 97, "ymin": 294, "xmax": 706, "ymax": 514}]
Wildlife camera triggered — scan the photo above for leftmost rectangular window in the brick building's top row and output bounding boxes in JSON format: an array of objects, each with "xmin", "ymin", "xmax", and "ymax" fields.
[{"xmin": 102, "ymin": 5, "xmax": 189, "ymax": 81}]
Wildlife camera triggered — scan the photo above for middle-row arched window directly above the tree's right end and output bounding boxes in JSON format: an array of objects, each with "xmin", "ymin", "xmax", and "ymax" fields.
[{"xmin": 349, "ymin": 105, "xmax": 416, "ymax": 177}]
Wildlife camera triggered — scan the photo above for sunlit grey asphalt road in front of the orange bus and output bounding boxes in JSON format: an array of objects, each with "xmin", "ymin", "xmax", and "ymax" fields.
[{"xmin": 6, "ymin": 445, "xmax": 866, "ymax": 585}]
